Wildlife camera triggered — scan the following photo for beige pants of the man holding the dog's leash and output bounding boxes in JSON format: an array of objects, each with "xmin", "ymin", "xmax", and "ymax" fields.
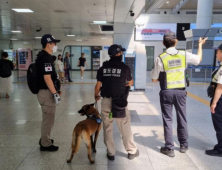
[{"xmin": 101, "ymin": 98, "xmax": 137, "ymax": 156}]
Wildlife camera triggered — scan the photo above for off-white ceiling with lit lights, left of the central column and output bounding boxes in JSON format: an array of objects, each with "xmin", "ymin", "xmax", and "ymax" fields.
[{"xmin": 0, "ymin": 0, "xmax": 115, "ymax": 40}]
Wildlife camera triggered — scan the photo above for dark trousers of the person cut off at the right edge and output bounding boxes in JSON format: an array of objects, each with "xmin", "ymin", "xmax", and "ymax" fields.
[{"xmin": 211, "ymin": 97, "xmax": 222, "ymax": 152}]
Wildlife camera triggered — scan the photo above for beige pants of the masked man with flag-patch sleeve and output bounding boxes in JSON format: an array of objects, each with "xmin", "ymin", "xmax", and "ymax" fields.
[{"xmin": 37, "ymin": 90, "xmax": 56, "ymax": 147}]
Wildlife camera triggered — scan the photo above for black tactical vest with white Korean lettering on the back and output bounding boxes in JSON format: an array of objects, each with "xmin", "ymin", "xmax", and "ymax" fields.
[{"xmin": 101, "ymin": 61, "xmax": 126, "ymax": 98}]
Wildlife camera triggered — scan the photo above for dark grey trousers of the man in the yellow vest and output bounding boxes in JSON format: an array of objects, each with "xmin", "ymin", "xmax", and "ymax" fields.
[{"xmin": 160, "ymin": 90, "xmax": 188, "ymax": 149}]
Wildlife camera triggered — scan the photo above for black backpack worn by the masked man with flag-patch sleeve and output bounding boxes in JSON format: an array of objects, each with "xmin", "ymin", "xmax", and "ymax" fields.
[{"xmin": 27, "ymin": 63, "xmax": 39, "ymax": 94}]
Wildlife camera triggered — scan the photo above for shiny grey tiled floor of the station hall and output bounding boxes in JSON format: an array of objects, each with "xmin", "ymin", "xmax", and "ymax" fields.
[{"xmin": 0, "ymin": 72, "xmax": 222, "ymax": 170}]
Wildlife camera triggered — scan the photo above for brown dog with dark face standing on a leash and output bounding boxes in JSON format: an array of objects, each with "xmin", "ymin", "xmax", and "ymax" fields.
[{"xmin": 67, "ymin": 104, "xmax": 102, "ymax": 164}]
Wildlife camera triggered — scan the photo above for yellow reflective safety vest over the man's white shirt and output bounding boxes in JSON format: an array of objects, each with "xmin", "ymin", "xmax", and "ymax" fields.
[{"xmin": 159, "ymin": 51, "xmax": 186, "ymax": 90}]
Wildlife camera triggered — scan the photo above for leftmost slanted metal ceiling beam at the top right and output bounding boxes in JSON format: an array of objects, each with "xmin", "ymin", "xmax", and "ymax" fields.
[{"xmin": 145, "ymin": 0, "xmax": 167, "ymax": 14}]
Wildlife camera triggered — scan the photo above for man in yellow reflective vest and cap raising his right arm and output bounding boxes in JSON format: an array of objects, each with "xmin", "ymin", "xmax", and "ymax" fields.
[{"xmin": 151, "ymin": 32, "xmax": 207, "ymax": 157}]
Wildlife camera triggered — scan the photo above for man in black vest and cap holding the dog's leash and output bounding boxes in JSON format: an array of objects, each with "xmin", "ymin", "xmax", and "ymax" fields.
[{"xmin": 95, "ymin": 44, "xmax": 139, "ymax": 161}]
